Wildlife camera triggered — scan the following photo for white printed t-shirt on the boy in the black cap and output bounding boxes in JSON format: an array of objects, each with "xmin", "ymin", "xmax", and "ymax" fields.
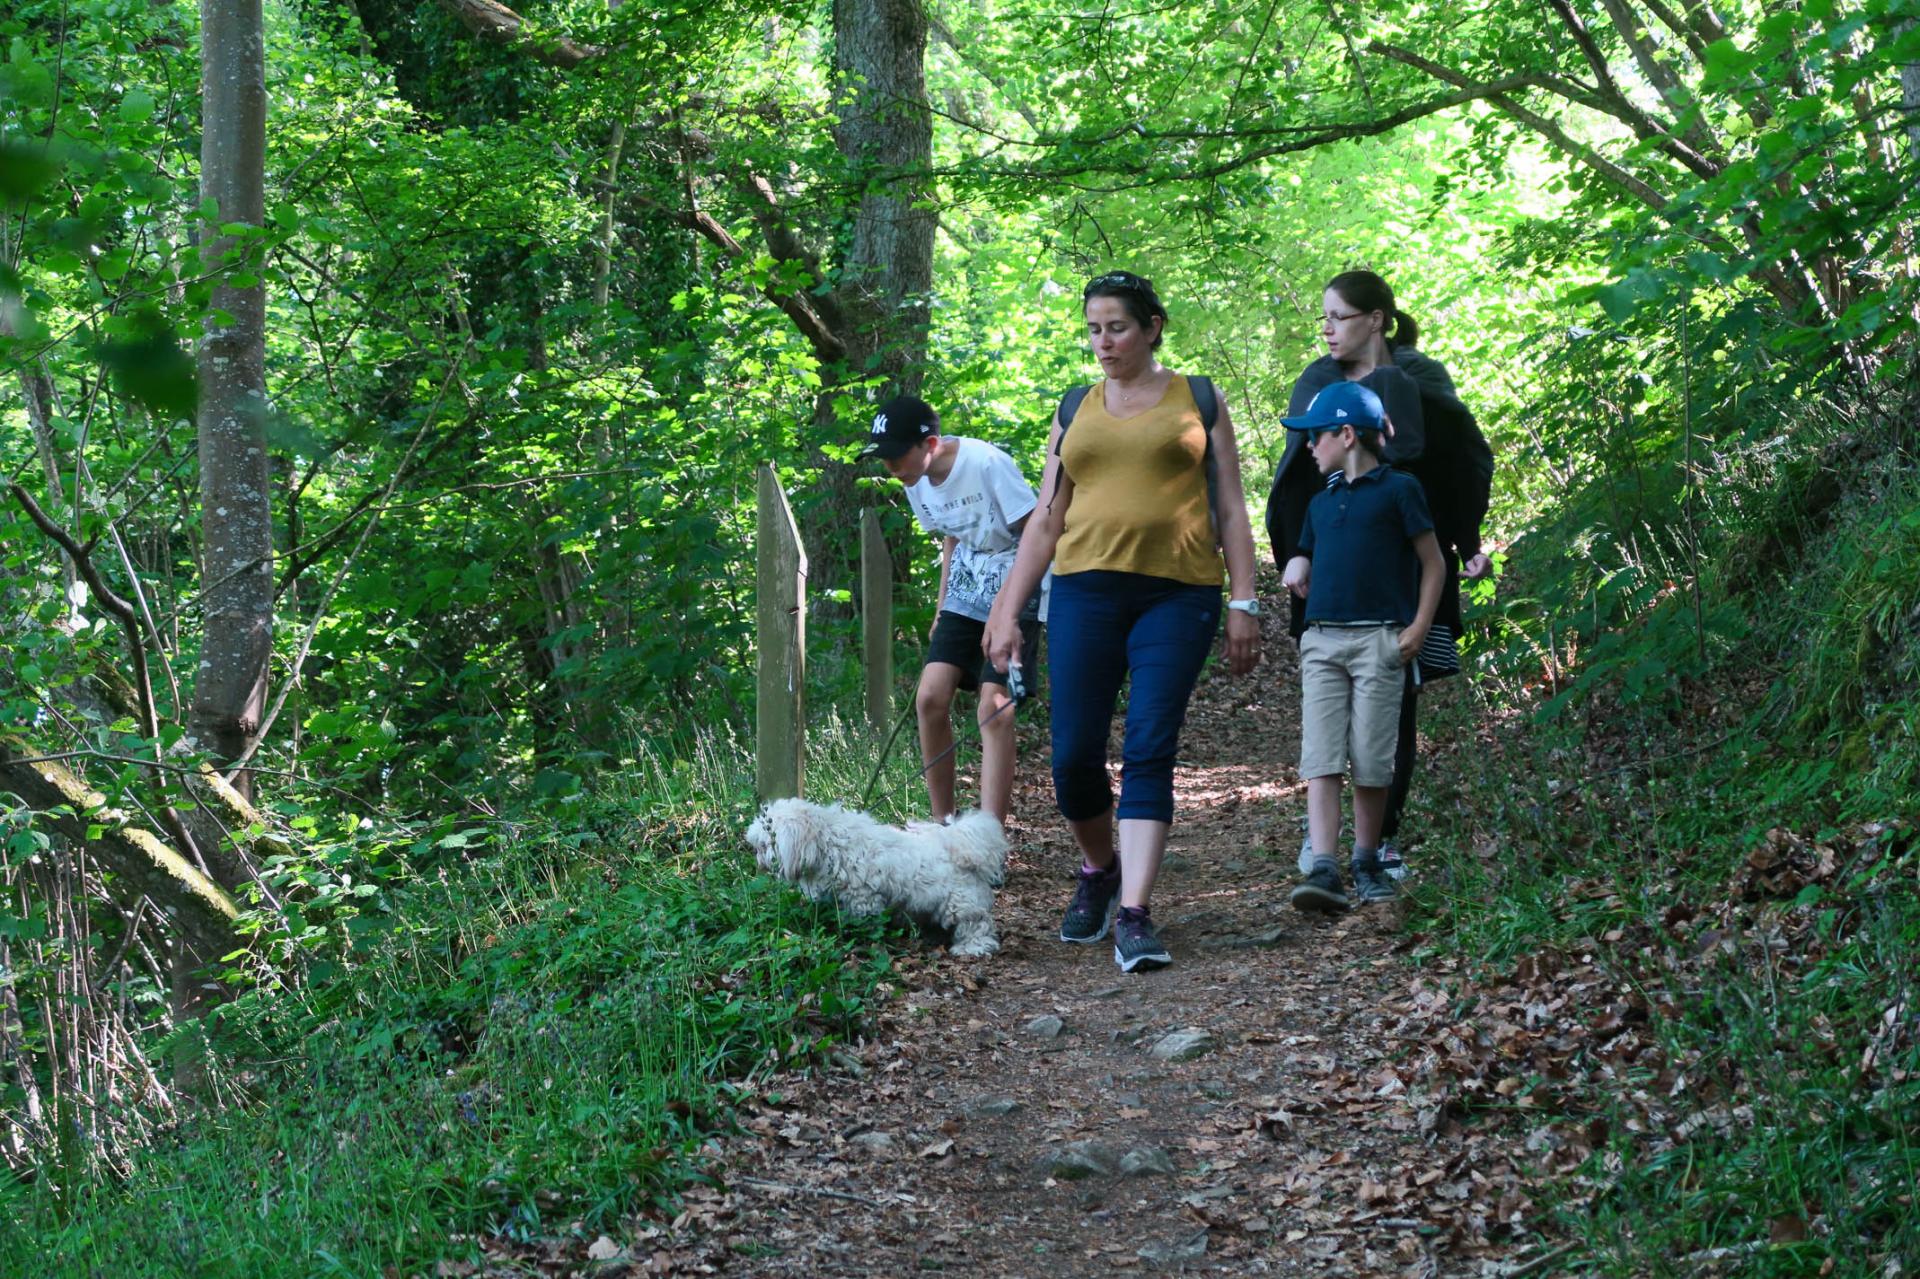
[{"xmin": 906, "ymin": 436, "xmax": 1044, "ymax": 622}]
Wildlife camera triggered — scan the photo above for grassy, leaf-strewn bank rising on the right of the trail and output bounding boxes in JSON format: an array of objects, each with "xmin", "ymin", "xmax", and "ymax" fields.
[{"xmin": 1415, "ymin": 362, "xmax": 1920, "ymax": 1275}]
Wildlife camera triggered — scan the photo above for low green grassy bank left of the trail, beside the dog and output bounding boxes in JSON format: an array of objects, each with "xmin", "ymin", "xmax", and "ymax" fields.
[{"xmin": 0, "ymin": 722, "xmax": 889, "ymax": 1275}]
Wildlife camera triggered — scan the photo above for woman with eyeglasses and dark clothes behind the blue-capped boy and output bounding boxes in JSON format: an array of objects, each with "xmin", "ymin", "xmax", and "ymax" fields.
[{"xmin": 1267, "ymin": 271, "xmax": 1494, "ymax": 901}]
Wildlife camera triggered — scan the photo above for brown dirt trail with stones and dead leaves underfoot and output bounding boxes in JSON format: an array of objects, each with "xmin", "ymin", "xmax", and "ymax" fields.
[{"xmin": 637, "ymin": 618, "xmax": 1551, "ymax": 1279}]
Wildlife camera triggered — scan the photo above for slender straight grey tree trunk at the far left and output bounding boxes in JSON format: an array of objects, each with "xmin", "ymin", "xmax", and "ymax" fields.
[{"xmin": 188, "ymin": 0, "xmax": 273, "ymax": 789}]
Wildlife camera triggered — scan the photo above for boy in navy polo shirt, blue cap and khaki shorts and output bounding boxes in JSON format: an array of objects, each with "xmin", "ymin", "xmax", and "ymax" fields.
[{"xmin": 1281, "ymin": 382, "xmax": 1446, "ymax": 914}]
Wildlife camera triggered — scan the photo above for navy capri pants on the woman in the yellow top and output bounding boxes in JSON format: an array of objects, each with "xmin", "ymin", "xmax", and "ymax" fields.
[{"xmin": 1046, "ymin": 568, "xmax": 1221, "ymax": 822}]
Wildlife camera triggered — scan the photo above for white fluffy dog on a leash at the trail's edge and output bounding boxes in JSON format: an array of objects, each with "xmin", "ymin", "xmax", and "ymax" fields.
[{"xmin": 747, "ymin": 799, "xmax": 1006, "ymax": 956}]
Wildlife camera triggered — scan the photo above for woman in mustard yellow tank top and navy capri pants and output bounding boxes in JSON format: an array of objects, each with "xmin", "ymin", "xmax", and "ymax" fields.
[{"xmin": 983, "ymin": 271, "xmax": 1260, "ymax": 972}]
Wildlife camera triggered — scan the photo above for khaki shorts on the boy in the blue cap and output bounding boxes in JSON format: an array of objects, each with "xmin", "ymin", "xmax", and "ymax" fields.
[{"xmin": 1300, "ymin": 626, "xmax": 1405, "ymax": 785}]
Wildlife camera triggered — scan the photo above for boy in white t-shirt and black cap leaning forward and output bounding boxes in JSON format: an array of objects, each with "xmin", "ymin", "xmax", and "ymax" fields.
[{"xmin": 860, "ymin": 396, "xmax": 1041, "ymax": 824}]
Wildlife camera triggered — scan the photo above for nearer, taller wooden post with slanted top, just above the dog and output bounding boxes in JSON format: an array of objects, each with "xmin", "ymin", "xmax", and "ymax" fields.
[{"xmin": 755, "ymin": 463, "xmax": 806, "ymax": 801}]
